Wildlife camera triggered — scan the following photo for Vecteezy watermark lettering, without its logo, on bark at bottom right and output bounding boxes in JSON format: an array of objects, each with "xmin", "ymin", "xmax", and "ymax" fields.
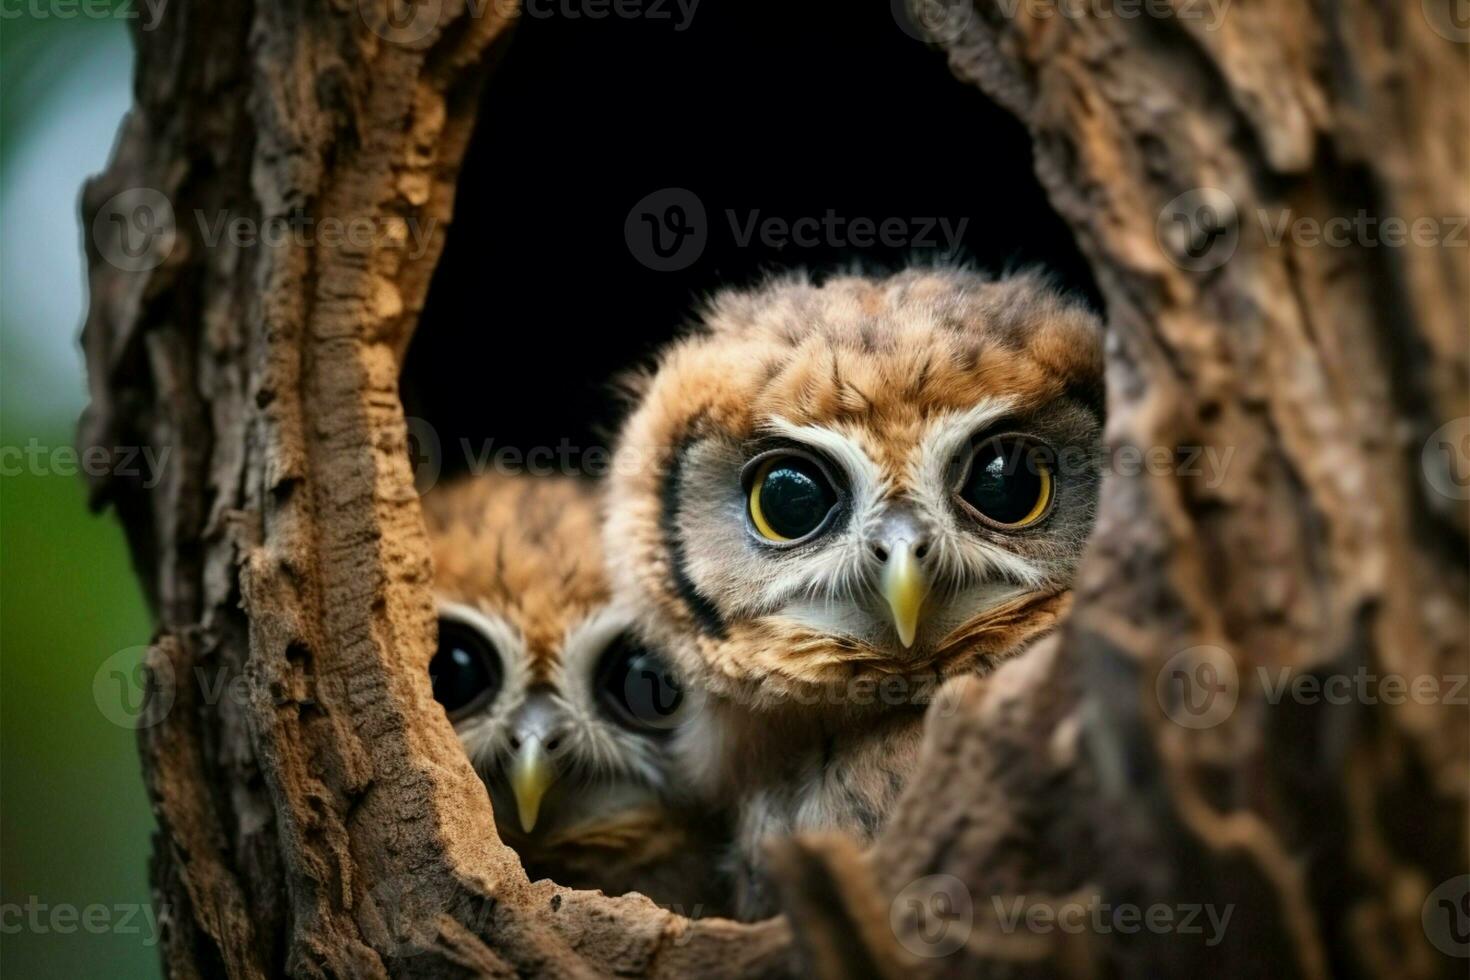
[{"xmin": 991, "ymin": 895, "xmax": 1235, "ymax": 946}]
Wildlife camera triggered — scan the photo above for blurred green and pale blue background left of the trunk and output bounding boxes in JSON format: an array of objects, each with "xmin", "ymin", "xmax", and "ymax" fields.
[{"xmin": 0, "ymin": 0, "xmax": 160, "ymax": 979}]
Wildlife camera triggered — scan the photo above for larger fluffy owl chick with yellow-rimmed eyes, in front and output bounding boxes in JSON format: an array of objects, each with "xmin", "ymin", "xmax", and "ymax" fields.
[{"xmin": 606, "ymin": 269, "xmax": 1103, "ymax": 917}]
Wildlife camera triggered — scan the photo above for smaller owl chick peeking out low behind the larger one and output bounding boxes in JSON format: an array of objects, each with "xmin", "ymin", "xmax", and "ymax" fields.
[{"xmin": 423, "ymin": 475, "xmax": 728, "ymax": 914}]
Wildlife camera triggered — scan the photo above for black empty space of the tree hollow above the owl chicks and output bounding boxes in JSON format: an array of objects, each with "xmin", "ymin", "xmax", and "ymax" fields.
[{"xmin": 403, "ymin": 0, "xmax": 1098, "ymax": 476}]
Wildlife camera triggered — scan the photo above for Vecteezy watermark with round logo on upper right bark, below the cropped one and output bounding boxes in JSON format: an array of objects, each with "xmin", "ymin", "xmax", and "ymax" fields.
[{"xmin": 1154, "ymin": 187, "xmax": 1470, "ymax": 272}]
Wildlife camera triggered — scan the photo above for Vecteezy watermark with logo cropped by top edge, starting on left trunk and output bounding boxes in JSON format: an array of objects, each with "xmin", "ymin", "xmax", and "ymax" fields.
[{"xmin": 357, "ymin": 0, "xmax": 701, "ymax": 47}]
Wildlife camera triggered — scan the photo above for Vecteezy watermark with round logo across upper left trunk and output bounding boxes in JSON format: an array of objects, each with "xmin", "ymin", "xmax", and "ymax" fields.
[{"xmin": 93, "ymin": 187, "xmax": 438, "ymax": 272}]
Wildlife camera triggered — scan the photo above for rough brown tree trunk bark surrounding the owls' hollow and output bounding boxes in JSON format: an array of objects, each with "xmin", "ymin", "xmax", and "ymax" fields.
[{"xmin": 81, "ymin": 0, "xmax": 1470, "ymax": 977}]
